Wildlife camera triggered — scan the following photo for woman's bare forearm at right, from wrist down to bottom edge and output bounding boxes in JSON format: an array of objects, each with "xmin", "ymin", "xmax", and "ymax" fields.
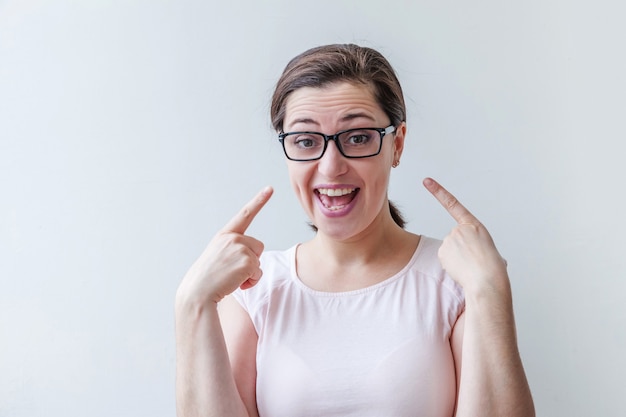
[{"xmin": 456, "ymin": 279, "xmax": 535, "ymax": 417}]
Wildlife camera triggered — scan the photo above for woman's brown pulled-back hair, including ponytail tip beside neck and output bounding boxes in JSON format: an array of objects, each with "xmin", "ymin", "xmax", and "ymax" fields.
[{"xmin": 270, "ymin": 44, "xmax": 406, "ymax": 227}]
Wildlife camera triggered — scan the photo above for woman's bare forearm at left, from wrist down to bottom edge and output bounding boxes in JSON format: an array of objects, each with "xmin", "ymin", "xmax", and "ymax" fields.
[{"xmin": 176, "ymin": 295, "xmax": 248, "ymax": 417}]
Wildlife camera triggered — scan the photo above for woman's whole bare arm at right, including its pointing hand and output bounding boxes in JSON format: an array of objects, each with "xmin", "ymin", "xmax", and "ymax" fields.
[{"xmin": 424, "ymin": 179, "xmax": 535, "ymax": 417}]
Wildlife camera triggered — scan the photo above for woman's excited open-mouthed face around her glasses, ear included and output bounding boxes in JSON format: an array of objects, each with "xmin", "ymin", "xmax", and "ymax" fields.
[{"xmin": 284, "ymin": 82, "xmax": 406, "ymax": 241}]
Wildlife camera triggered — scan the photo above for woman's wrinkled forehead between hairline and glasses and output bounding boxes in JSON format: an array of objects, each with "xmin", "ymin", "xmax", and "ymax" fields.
[{"xmin": 284, "ymin": 82, "xmax": 385, "ymax": 129}]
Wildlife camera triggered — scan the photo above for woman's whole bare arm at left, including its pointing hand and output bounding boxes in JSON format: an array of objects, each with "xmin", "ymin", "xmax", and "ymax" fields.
[{"xmin": 175, "ymin": 189, "xmax": 272, "ymax": 417}]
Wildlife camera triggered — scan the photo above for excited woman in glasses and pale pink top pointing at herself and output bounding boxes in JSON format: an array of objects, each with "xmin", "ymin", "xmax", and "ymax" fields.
[{"xmin": 176, "ymin": 45, "xmax": 534, "ymax": 417}]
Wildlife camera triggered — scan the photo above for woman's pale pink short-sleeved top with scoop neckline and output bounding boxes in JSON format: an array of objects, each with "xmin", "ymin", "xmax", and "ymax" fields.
[{"xmin": 235, "ymin": 237, "xmax": 465, "ymax": 417}]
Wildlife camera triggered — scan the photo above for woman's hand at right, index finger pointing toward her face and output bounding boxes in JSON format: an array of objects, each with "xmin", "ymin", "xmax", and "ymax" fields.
[{"xmin": 424, "ymin": 178, "xmax": 509, "ymax": 295}]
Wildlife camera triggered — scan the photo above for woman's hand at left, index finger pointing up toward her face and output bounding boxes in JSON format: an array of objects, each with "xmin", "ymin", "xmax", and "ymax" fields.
[{"xmin": 177, "ymin": 187, "xmax": 273, "ymax": 304}]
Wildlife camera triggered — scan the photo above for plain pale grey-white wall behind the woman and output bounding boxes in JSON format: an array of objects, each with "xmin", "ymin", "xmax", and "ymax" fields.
[{"xmin": 0, "ymin": 0, "xmax": 626, "ymax": 417}]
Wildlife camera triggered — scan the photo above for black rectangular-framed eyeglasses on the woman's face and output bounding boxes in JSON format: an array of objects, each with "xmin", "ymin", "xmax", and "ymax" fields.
[{"xmin": 278, "ymin": 125, "xmax": 396, "ymax": 161}]
